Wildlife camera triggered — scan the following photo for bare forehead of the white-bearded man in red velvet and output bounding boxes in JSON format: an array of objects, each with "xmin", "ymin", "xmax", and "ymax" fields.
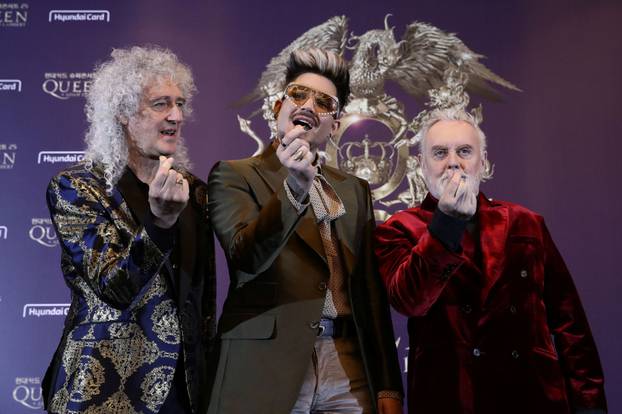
[{"xmin": 422, "ymin": 120, "xmax": 481, "ymax": 150}]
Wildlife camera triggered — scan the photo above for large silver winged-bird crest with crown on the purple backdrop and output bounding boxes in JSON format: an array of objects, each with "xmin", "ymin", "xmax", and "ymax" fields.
[{"xmin": 238, "ymin": 15, "xmax": 519, "ymax": 221}]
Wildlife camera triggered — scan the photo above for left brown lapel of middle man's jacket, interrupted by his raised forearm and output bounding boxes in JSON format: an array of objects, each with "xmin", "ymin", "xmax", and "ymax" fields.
[{"xmin": 253, "ymin": 144, "xmax": 327, "ymax": 263}]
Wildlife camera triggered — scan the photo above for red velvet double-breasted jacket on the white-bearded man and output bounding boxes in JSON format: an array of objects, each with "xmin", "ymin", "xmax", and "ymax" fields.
[{"xmin": 375, "ymin": 193, "xmax": 606, "ymax": 414}]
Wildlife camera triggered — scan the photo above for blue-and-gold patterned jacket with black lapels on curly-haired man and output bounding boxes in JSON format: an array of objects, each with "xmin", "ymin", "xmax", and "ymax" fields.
[{"xmin": 43, "ymin": 164, "xmax": 215, "ymax": 414}]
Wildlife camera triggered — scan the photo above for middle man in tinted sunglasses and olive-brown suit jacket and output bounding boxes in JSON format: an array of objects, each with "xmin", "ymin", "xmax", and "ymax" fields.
[{"xmin": 208, "ymin": 49, "xmax": 402, "ymax": 414}]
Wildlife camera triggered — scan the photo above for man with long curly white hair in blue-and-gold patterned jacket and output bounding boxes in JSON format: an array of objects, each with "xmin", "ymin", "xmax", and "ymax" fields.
[{"xmin": 43, "ymin": 47, "xmax": 215, "ymax": 413}]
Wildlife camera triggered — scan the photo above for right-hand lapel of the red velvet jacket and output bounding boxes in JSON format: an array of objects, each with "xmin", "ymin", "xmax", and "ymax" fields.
[{"xmin": 479, "ymin": 193, "xmax": 509, "ymax": 303}]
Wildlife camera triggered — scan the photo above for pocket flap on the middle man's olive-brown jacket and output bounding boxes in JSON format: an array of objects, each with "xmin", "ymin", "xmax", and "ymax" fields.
[{"xmin": 221, "ymin": 314, "xmax": 276, "ymax": 339}]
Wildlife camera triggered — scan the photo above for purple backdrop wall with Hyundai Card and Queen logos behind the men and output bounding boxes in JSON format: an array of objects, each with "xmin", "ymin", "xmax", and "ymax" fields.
[{"xmin": 0, "ymin": 0, "xmax": 622, "ymax": 414}]
